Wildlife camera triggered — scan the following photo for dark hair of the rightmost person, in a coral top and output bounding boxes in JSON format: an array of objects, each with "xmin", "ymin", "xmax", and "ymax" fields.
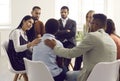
[{"xmin": 106, "ymin": 19, "xmax": 115, "ymax": 35}]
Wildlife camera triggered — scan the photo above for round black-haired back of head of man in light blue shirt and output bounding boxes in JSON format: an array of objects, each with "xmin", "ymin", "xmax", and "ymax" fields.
[{"xmin": 45, "ymin": 18, "xmax": 59, "ymax": 35}]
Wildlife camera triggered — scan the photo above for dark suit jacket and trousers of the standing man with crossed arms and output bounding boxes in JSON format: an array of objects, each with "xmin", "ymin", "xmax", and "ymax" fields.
[{"xmin": 56, "ymin": 18, "xmax": 76, "ymax": 68}]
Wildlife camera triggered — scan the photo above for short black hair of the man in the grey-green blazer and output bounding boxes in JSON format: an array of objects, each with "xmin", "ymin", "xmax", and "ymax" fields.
[{"xmin": 93, "ymin": 14, "xmax": 107, "ymax": 27}]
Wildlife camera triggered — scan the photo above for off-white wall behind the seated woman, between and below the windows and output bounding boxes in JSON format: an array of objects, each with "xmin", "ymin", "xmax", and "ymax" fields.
[{"xmin": 0, "ymin": 0, "xmax": 55, "ymax": 55}]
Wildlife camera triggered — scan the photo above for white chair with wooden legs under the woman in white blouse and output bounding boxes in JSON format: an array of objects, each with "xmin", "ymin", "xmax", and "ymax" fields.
[{"xmin": 2, "ymin": 41, "xmax": 26, "ymax": 81}]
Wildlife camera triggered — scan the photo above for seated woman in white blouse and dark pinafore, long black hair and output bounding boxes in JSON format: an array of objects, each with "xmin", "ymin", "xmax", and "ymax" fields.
[{"xmin": 8, "ymin": 15, "xmax": 40, "ymax": 81}]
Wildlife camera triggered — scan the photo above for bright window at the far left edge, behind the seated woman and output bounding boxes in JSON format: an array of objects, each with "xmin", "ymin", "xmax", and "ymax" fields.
[{"xmin": 0, "ymin": 0, "xmax": 10, "ymax": 28}]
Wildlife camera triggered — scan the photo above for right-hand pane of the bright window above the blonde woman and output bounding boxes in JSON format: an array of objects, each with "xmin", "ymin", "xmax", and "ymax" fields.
[{"xmin": 81, "ymin": 0, "xmax": 105, "ymax": 24}]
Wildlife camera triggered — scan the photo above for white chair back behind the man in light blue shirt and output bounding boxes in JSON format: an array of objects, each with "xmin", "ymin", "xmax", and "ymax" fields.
[{"xmin": 24, "ymin": 58, "xmax": 54, "ymax": 81}]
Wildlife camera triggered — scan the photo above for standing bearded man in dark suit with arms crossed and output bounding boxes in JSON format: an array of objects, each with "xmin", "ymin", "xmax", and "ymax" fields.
[{"xmin": 56, "ymin": 6, "xmax": 76, "ymax": 71}]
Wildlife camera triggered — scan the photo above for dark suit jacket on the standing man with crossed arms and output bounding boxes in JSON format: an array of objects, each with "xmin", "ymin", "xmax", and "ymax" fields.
[{"xmin": 56, "ymin": 18, "xmax": 76, "ymax": 48}]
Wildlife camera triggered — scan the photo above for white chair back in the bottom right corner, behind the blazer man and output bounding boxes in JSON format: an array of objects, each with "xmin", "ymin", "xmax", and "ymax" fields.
[{"xmin": 87, "ymin": 60, "xmax": 120, "ymax": 81}]
